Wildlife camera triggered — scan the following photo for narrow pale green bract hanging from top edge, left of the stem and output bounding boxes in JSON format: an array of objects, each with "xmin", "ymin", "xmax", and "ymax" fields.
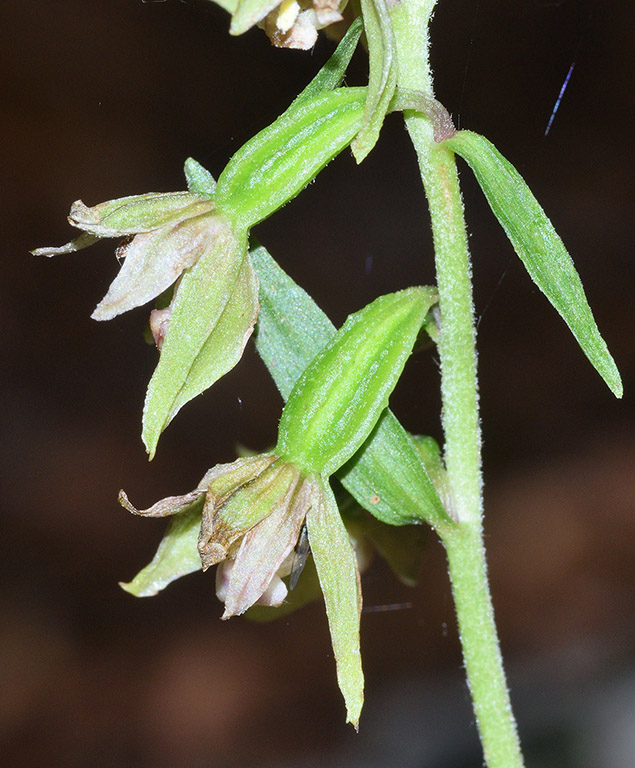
[{"xmin": 351, "ymin": 0, "xmax": 397, "ymax": 163}]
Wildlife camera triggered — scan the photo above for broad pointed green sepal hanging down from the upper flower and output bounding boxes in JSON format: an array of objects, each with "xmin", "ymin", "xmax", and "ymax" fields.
[{"xmin": 143, "ymin": 225, "xmax": 258, "ymax": 458}]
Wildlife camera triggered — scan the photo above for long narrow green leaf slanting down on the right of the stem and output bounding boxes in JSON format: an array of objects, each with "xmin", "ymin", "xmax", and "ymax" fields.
[{"xmin": 443, "ymin": 131, "xmax": 622, "ymax": 397}]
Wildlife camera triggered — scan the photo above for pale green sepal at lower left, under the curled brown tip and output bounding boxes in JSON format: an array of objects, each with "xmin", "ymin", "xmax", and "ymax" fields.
[{"xmin": 119, "ymin": 496, "xmax": 204, "ymax": 597}]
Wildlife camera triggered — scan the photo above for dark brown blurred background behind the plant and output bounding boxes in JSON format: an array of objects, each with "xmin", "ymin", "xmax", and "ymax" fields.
[{"xmin": 0, "ymin": 0, "xmax": 635, "ymax": 768}]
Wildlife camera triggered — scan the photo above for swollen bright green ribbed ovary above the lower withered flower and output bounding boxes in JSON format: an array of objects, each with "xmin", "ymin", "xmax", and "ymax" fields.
[{"xmin": 276, "ymin": 288, "xmax": 436, "ymax": 475}]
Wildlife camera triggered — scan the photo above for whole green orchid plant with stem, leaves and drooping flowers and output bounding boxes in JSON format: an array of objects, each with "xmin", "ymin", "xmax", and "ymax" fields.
[{"xmin": 36, "ymin": 0, "xmax": 622, "ymax": 768}]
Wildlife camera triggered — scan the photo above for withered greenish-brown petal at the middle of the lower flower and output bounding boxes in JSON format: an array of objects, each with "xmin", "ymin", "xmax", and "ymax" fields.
[{"xmin": 198, "ymin": 455, "xmax": 288, "ymax": 570}]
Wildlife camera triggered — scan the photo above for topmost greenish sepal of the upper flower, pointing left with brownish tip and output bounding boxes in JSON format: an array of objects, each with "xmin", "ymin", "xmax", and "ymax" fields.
[{"xmin": 68, "ymin": 192, "xmax": 214, "ymax": 237}]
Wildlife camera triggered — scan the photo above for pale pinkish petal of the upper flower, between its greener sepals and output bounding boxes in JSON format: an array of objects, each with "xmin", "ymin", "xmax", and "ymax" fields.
[{"xmin": 92, "ymin": 214, "xmax": 226, "ymax": 320}]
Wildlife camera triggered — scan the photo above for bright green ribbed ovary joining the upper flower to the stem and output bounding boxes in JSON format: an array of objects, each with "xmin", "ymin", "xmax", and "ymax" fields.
[{"xmin": 215, "ymin": 88, "xmax": 366, "ymax": 229}]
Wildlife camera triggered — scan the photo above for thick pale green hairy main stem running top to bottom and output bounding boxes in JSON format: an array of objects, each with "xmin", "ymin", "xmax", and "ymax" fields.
[{"xmin": 391, "ymin": 0, "xmax": 523, "ymax": 768}]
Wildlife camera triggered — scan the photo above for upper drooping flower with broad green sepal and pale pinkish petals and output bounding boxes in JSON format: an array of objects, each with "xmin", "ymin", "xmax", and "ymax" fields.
[{"xmin": 34, "ymin": 158, "xmax": 258, "ymax": 458}]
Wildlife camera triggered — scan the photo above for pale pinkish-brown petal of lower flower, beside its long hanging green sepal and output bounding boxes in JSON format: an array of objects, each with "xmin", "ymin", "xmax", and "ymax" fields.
[{"xmin": 223, "ymin": 465, "xmax": 311, "ymax": 619}]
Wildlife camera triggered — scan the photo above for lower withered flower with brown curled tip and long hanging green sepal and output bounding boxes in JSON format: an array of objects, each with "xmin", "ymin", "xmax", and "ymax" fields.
[{"xmin": 119, "ymin": 453, "xmax": 364, "ymax": 727}]
